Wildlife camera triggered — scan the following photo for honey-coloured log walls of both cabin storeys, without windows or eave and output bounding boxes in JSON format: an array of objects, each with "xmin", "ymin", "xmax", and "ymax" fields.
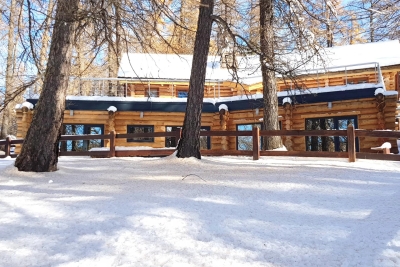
[{"xmin": 13, "ymin": 66, "xmax": 400, "ymax": 151}]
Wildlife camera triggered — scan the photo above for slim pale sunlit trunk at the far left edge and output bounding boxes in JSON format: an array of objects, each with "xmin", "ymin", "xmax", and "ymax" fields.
[{"xmin": 0, "ymin": 0, "xmax": 16, "ymax": 139}]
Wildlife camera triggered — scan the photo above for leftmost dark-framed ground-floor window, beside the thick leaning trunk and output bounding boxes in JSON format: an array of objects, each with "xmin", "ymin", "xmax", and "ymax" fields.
[{"xmin": 60, "ymin": 124, "xmax": 104, "ymax": 151}]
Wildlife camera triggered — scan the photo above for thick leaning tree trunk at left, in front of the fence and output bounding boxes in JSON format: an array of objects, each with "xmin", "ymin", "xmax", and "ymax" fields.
[{"xmin": 15, "ymin": 0, "xmax": 79, "ymax": 172}]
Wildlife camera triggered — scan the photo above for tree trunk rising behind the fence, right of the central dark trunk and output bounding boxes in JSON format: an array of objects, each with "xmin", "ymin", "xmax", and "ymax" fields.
[{"xmin": 260, "ymin": 0, "xmax": 281, "ymax": 150}]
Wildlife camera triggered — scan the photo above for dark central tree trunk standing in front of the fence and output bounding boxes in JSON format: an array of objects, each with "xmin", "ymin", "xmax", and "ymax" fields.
[{"xmin": 177, "ymin": 0, "xmax": 214, "ymax": 159}]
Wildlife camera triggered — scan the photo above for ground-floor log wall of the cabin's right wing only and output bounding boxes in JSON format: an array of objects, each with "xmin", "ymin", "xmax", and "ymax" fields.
[{"xmin": 225, "ymin": 96, "xmax": 397, "ymax": 152}]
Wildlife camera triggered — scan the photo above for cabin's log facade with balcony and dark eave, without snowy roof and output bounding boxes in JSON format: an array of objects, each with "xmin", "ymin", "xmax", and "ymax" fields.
[{"xmin": 16, "ymin": 43, "xmax": 400, "ymax": 152}]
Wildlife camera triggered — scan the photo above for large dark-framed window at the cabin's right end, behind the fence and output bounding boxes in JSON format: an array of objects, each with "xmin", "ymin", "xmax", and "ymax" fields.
[{"xmin": 306, "ymin": 116, "xmax": 358, "ymax": 152}]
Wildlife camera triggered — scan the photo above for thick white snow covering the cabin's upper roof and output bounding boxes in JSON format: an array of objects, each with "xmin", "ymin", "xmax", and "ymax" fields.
[{"xmin": 118, "ymin": 40, "xmax": 400, "ymax": 84}]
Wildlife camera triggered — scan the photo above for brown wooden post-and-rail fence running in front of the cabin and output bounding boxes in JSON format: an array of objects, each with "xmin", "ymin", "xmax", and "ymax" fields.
[{"xmin": 0, "ymin": 125, "xmax": 400, "ymax": 162}]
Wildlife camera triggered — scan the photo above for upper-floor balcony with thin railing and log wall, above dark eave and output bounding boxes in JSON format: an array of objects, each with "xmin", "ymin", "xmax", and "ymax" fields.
[{"xmin": 24, "ymin": 62, "xmax": 386, "ymax": 100}]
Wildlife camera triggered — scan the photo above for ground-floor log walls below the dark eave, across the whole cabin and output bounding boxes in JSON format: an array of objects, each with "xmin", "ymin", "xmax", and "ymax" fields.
[{"xmin": 16, "ymin": 96, "xmax": 397, "ymax": 152}]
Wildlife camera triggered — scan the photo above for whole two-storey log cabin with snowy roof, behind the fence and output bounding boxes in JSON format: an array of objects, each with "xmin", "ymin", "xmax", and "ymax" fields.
[{"xmin": 16, "ymin": 40, "xmax": 400, "ymax": 152}]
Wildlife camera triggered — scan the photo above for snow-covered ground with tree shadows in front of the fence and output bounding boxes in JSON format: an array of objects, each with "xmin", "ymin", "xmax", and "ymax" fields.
[{"xmin": 0, "ymin": 156, "xmax": 400, "ymax": 267}]
